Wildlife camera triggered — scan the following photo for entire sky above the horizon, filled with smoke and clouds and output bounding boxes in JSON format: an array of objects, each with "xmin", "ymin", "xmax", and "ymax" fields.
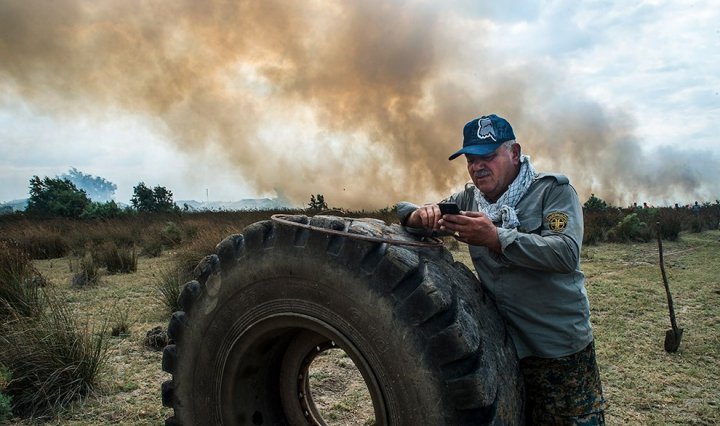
[{"xmin": 0, "ymin": 0, "xmax": 720, "ymax": 208}]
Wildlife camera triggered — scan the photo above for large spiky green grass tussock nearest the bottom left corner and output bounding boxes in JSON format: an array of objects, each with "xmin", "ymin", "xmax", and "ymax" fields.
[{"xmin": 0, "ymin": 292, "xmax": 107, "ymax": 417}]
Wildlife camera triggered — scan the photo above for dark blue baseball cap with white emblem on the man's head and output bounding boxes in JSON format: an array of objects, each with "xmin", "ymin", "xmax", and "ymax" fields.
[{"xmin": 448, "ymin": 114, "xmax": 515, "ymax": 160}]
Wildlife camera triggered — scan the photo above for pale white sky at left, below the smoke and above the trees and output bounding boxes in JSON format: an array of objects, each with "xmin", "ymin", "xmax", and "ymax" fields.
[{"xmin": 0, "ymin": 99, "xmax": 255, "ymax": 203}]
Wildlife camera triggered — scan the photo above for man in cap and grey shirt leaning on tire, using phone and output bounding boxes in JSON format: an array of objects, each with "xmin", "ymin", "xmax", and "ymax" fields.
[{"xmin": 398, "ymin": 114, "xmax": 605, "ymax": 425}]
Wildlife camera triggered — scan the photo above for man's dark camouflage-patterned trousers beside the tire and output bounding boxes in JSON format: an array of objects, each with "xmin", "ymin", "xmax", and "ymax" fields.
[{"xmin": 520, "ymin": 343, "xmax": 605, "ymax": 425}]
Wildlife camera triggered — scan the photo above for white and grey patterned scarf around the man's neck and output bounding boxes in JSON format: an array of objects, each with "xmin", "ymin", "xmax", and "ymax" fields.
[{"xmin": 475, "ymin": 155, "xmax": 537, "ymax": 229}]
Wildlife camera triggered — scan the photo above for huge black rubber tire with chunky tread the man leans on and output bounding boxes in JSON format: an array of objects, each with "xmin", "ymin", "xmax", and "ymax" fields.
[{"xmin": 162, "ymin": 216, "xmax": 523, "ymax": 426}]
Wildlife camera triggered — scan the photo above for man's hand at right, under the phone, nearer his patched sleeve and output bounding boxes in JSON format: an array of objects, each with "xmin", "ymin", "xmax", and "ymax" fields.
[{"xmin": 438, "ymin": 209, "xmax": 502, "ymax": 253}]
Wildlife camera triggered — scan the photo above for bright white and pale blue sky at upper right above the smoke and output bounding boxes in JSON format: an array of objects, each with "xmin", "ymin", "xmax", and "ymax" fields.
[{"xmin": 467, "ymin": 0, "xmax": 720, "ymax": 153}]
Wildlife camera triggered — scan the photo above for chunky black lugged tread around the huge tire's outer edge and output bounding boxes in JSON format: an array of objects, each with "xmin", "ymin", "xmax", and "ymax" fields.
[{"xmin": 162, "ymin": 215, "xmax": 521, "ymax": 424}]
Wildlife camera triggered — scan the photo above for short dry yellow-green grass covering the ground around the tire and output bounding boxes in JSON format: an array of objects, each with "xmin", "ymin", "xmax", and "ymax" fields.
[{"xmin": 2, "ymin": 231, "xmax": 720, "ymax": 425}]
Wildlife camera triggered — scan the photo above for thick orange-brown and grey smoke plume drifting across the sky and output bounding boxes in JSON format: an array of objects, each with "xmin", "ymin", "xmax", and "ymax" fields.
[{"xmin": 0, "ymin": 0, "xmax": 720, "ymax": 208}]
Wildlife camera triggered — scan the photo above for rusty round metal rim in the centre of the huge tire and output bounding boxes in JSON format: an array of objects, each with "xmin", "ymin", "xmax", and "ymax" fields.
[{"xmin": 216, "ymin": 313, "xmax": 389, "ymax": 426}]
